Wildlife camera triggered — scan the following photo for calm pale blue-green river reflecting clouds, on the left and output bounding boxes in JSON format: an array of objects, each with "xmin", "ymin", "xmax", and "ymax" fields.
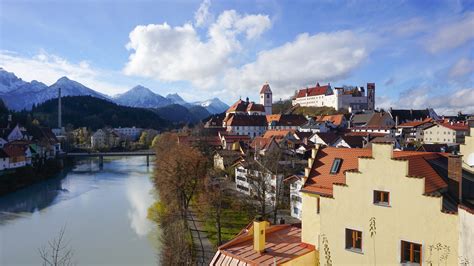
[{"xmin": 0, "ymin": 157, "xmax": 160, "ymax": 265}]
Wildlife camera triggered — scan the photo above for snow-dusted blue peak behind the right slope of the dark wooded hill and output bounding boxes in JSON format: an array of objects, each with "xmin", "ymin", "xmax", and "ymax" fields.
[{"xmin": 113, "ymin": 85, "xmax": 173, "ymax": 108}]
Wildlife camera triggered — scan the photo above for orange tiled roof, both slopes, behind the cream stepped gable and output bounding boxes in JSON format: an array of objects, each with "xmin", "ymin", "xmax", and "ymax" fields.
[{"xmin": 302, "ymin": 147, "xmax": 447, "ymax": 197}]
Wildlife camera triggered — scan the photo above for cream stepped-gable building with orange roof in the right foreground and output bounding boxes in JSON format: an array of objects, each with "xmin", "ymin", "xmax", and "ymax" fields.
[{"xmin": 301, "ymin": 143, "xmax": 474, "ymax": 265}]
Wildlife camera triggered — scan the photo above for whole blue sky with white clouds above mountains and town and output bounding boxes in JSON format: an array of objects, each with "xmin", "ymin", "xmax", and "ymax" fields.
[{"xmin": 0, "ymin": 0, "xmax": 474, "ymax": 114}]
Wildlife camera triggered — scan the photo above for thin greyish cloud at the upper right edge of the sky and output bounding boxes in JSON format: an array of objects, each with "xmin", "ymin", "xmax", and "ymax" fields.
[{"xmin": 425, "ymin": 12, "xmax": 474, "ymax": 53}]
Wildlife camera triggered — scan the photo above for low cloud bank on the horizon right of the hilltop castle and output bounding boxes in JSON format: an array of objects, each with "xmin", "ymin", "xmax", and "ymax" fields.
[{"xmin": 376, "ymin": 86, "xmax": 474, "ymax": 115}]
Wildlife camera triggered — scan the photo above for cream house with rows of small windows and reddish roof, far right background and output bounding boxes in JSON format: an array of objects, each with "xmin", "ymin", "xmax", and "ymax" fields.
[{"xmin": 423, "ymin": 122, "xmax": 469, "ymax": 144}]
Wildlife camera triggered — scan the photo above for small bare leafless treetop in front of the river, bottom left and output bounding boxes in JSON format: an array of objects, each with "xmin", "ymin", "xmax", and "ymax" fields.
[{"xmin": 39, "ymin": 227, "xmax": 74, "ymax": 266}]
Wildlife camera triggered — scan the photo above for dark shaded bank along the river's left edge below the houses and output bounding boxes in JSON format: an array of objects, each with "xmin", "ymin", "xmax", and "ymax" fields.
[{"xmin": 0, "ymin": 159, "xmax": 72, "ymax": 196}]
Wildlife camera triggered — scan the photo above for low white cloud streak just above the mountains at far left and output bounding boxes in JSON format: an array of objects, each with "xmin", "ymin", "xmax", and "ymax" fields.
[{"xmin": 0, "ymin": 50, "xmax": 127, "ymax": 95}]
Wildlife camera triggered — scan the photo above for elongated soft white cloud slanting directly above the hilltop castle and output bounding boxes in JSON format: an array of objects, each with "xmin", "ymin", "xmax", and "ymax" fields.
[{"xmin": 224, "ymin": 31, "xmax": 369, "ymax": 100}]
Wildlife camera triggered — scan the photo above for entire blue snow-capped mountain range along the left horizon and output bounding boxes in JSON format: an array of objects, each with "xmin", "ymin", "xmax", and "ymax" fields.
[{"xmin": 0, "ymin": 68, "xmax": 229, "ymax": 116}]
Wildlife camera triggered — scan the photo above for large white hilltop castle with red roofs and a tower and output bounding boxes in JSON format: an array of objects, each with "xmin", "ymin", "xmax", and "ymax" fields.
[{"xmin": 292, "ymin": 83, "xmax": 375, "ymax": 112}]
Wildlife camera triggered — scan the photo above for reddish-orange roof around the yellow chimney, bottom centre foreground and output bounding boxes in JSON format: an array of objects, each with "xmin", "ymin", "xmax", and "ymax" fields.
[{"xmin": 210, "ymin": 224, "xmax": 315, "ymax": 265}]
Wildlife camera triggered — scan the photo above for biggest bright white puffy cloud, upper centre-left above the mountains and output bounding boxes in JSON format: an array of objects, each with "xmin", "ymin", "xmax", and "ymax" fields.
[{"xmin": 124, "ymin": 10, "xmax": 271, "ymax": 88}]
